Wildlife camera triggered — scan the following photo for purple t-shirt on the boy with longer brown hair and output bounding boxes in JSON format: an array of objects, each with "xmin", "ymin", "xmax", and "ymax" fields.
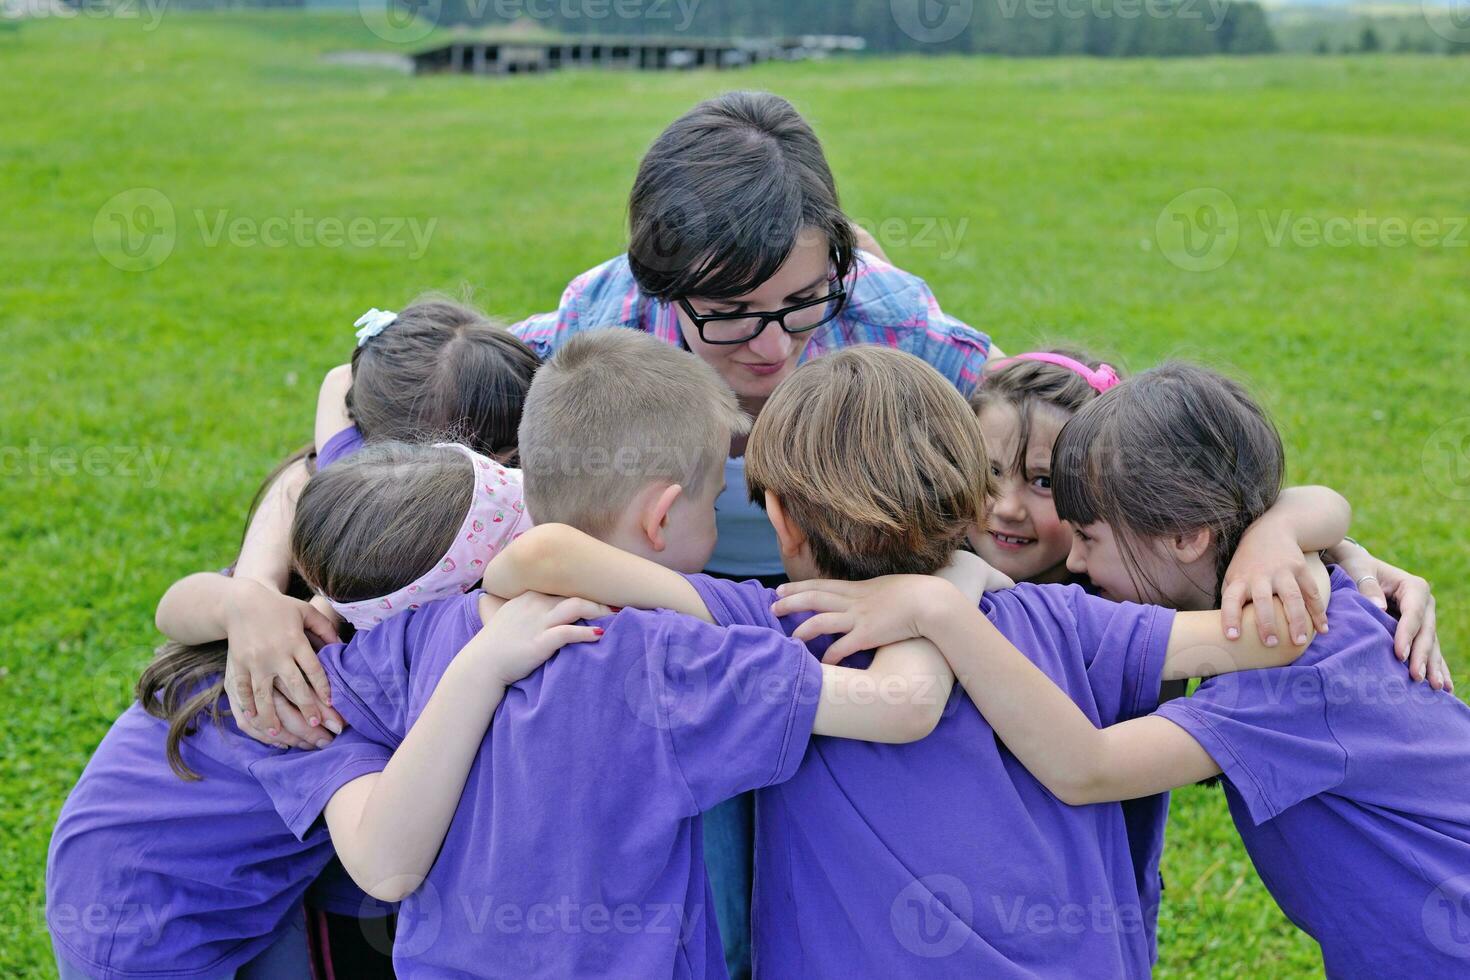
[{"xmin": 691, "ymin": 576, "xmax": 1173, "ymax": 979}]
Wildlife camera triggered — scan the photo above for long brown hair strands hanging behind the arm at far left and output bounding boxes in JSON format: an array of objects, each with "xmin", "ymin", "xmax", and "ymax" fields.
[{"xmin": 134, "ymin": 445, "xmax": 316, "ymax": 782}]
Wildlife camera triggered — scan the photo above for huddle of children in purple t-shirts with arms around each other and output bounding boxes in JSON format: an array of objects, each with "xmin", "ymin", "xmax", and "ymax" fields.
[{"xmin": 47, "ymin": 293, "xmax": 1470, "ymax": 980}]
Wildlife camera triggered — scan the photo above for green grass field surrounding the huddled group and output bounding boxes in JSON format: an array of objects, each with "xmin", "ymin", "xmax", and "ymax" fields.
[{"xmin": 0, "ymin": 13, "xmax": 1470, "ymax": 977}]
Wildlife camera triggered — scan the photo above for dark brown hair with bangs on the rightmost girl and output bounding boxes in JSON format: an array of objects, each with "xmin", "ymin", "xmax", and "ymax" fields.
[{"xmin": 1051, "ymin": 361, "xmax": 1286, "ymax": 599}]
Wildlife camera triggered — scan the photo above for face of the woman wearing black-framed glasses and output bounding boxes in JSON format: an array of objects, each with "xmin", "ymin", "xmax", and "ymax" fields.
[{"xmin": 675, "ymin": 229, "xmax": 832, "ymax": 407}]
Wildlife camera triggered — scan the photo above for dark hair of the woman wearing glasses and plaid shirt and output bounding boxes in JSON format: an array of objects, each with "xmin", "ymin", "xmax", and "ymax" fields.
[{"xmin": 628, "ymin": 93, "xmax": 857, "ymax": 301}]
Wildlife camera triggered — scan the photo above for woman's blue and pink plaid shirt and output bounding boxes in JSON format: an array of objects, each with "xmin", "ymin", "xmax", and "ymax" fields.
[{"xmin": 510, "ymin": 253, "xmax": 991, "ymax": 397}]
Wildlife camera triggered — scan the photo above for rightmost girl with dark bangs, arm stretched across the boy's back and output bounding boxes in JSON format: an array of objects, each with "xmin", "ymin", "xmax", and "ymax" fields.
[{"xmin": 792, "ymin": 364, "xmax": 1470, "ymax": 977}]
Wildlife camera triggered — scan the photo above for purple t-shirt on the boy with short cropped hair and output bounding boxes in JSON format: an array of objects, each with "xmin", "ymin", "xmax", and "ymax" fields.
[{"xmin": 257, "ymin": 592, "xmax": 822, "ymax": 977}]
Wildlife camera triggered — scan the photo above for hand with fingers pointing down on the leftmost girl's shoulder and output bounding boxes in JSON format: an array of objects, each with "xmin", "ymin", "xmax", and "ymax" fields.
[{"xmin": 225, "ymin": 579, "xmax": 344, "ymax": 748}]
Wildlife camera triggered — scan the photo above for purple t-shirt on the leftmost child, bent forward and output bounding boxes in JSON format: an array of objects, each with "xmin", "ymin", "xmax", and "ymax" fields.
[{"xmin": 46, "ymin": 704, "xmax": 388, "ymax": 980}]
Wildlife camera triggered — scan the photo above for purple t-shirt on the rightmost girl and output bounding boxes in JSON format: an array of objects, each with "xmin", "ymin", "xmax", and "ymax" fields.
[{"xmin": 1158, "ymin": 569, "xmax": 1470, "ymax": 977}]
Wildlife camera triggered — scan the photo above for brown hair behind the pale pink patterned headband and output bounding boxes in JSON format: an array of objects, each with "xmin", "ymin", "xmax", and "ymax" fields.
[{"xmin": 291, "ymin": 442, "xmax": 475, "ymax": 602}]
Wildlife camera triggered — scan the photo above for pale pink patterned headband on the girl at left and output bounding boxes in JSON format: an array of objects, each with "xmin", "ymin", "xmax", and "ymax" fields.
[{"xmin": 332, "ymin": 442, "xmax": 531, "ymax": 630}]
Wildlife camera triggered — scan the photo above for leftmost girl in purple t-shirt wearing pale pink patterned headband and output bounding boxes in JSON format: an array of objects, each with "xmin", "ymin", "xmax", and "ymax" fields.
[{"xmin": 46, "ymin": 444, "xmax": 606, "ymax": 980}]
